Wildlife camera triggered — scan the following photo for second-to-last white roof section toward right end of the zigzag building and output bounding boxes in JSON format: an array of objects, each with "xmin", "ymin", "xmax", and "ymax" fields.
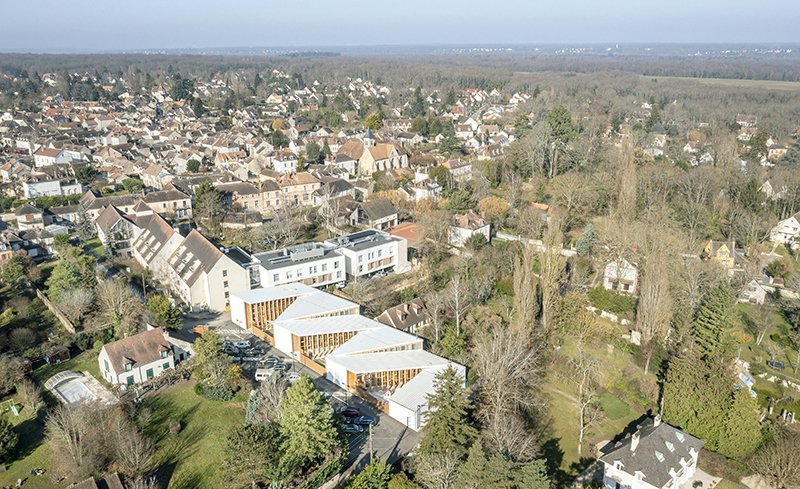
[{"xmin": 326, "ymin": 350, "xmax": 450, "ymax": 374}]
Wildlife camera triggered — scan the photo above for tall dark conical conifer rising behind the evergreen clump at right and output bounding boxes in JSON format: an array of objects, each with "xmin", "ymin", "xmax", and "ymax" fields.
[{"xmin": 693, "ymin": 284, "xmax": 736, "ymax": 365}]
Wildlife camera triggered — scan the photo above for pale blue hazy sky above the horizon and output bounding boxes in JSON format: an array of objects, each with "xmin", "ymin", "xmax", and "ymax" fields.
[{"xmin": 0, "ymin": 0, "xmax": 800, "ymax": 51}]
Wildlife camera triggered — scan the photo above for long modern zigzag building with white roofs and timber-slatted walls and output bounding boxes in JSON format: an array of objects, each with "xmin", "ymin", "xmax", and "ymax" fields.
[{"xmin": 231, "ymin": 283, "xmax": 466, "ymax": 430}]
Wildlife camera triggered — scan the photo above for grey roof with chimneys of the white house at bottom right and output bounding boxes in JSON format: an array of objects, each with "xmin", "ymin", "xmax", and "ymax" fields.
[{"xmin": 600, "ymin": 418, "xmax": 703, "ymax": 487}]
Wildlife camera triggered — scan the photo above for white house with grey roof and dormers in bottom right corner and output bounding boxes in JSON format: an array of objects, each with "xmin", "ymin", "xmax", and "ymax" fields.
[{"xmin": 600, "ymin": 417, "xmax": 703, "ymax": 489}]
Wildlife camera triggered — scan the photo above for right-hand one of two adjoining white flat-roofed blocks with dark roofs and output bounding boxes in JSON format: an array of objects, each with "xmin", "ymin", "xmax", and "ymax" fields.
[{"xmin": 325, "ymin": 229, "xmax": 410, "ymax": 277}]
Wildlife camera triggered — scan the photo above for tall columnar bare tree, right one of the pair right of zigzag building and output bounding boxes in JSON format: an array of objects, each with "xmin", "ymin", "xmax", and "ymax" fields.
[{"xmin": 539, "ymin": 217, "xmax": 566, "ymax": 333}]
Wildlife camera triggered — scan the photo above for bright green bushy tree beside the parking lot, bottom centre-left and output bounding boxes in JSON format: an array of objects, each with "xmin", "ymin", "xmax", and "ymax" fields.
[{"xmin": 280, "ymin": 375, "xmax": 338, "ymax": 468}]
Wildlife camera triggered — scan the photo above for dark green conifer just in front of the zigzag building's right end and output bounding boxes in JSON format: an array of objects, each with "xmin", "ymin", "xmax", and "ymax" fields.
[{"xmin": 420, "ymin": 366, "xmax": 477, "ymax": 453}]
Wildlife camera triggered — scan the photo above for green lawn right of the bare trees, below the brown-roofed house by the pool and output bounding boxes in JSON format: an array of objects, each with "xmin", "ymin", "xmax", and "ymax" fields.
[{"xmin": 145, "ymin": 382, "xmax": 244, "ymax": 489}]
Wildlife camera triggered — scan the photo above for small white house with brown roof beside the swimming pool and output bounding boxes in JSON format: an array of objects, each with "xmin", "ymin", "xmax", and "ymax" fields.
[{"xmin": 97, "ymin": 328, "xmax": 185, "ymax": 386}]
